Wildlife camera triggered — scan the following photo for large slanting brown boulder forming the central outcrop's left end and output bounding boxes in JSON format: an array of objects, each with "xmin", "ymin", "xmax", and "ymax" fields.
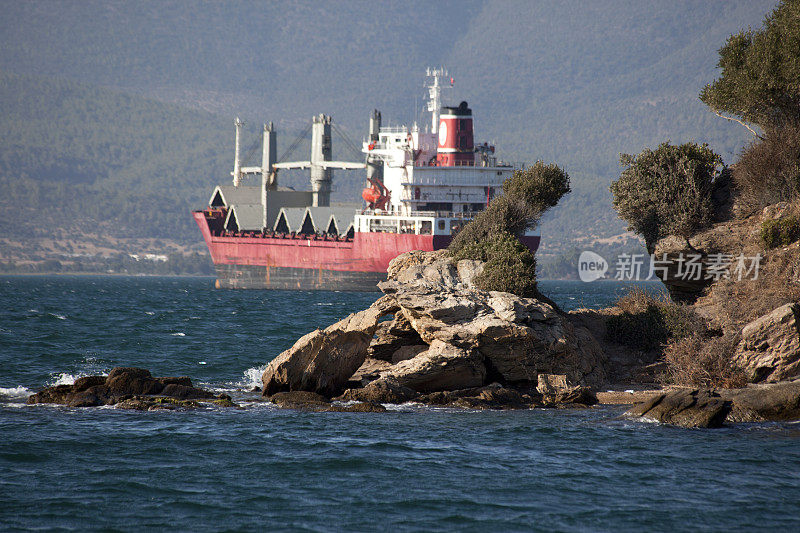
[{"xmin": 261, "ymin": 297, "xmax": 393, "ymax": 397}]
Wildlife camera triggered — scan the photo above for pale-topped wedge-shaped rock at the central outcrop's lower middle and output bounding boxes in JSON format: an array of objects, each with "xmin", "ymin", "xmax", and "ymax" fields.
[{"xmin": 381, "ymin": 340, "xmax": 486, "ymax": 392}]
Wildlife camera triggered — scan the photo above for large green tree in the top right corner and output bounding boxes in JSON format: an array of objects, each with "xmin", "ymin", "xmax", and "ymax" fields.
[{"xmin": 700, "ymin": 0, "xmax": 800, "ymax": 134}]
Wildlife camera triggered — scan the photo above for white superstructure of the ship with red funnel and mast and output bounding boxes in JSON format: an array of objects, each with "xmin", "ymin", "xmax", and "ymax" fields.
[{"xmin": 355, "ymin": 69, "xmax": 532, "ymax": 235}]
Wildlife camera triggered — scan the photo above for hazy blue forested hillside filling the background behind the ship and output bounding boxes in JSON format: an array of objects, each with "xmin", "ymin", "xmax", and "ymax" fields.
[{"xmin": 0, "ymin": 0, "xmax": 774, "ymax": 272}]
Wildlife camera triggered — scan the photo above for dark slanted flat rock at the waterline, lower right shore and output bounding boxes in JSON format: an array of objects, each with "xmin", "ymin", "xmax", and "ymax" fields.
[{"xmin": 625, "ymin": 390, "xmax": 732, "ymax": 428}]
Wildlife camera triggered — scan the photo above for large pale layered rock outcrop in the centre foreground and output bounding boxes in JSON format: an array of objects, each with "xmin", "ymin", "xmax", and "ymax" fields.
[{"xmin": 262, "ymin": 252, "xmax": 605, "ymax": 405}]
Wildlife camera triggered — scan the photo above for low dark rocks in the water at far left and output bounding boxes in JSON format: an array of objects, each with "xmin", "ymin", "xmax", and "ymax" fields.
[{"xmin": 28, "ymin": 367, "xmax": 228, "ymax": 410}]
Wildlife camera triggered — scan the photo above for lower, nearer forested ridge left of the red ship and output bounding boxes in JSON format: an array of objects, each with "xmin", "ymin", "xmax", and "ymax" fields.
[{"xmin": 0, "ymin": 73, "xmax": 232, "ymax": 238}]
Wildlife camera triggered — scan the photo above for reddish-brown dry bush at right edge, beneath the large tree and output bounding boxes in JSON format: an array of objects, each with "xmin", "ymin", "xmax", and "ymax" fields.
[{"xmin": 733, "ymin": 124, "xmax": 800, "ymax": 216}]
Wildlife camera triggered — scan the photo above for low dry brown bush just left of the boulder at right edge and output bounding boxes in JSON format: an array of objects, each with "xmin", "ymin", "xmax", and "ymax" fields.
[{"xmin": 662, "ymin": 334, "xmax": 747, "ymax": 388}]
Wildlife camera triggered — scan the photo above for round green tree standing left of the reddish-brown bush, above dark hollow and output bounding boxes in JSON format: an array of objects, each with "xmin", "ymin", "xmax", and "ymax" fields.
[{"xmin": 611, "ymin": 142, "xmax": 723, "ymax": 253}]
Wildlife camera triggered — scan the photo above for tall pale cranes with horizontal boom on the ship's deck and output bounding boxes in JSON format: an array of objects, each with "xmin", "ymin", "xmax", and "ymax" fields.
[{"xmin": 232, "ymin": 114, "xmax": 366, "ymax": 207}]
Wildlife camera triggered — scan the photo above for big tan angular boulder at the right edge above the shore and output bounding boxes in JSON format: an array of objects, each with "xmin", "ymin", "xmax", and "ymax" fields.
[{"xmin": 733, "ymin": 304, "xmax": 800, "ymax": 382}]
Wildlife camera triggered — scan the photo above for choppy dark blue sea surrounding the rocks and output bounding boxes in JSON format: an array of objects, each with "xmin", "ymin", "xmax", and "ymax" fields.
[{"xmin": 0, "ymin": 277, "xmax": 800, "ymax": 531}]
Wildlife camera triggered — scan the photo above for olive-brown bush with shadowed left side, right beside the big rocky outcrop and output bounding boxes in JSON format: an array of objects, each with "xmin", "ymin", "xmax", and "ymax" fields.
[{"xmin": 606, "ymin": 287, "xmax": 707, "ymax": 351}]
